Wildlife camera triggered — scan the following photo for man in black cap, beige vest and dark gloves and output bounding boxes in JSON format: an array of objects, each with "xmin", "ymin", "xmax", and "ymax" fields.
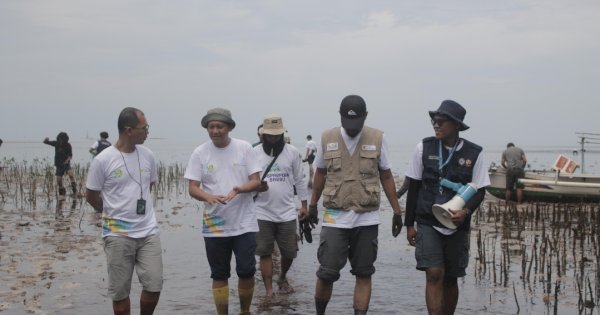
[{"xmin": 309, "ymin": 95, "xmax": 402, "ymax": 314}]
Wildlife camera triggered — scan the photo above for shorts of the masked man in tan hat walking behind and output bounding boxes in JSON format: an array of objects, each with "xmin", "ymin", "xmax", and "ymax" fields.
[{"xmin": 256, "ymin": 220, "xmax": 298, "ymax": 259}]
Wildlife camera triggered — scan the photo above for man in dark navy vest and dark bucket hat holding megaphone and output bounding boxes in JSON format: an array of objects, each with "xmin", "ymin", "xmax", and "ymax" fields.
[{"xmin": 405, "ymin": 100, "xmax": 490, "ymax": 315}]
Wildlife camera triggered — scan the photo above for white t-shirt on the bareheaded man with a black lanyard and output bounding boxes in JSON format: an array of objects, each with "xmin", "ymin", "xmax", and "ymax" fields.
[{"xmin": 85, "ymin": 145, "xmax": 158, "ymax": 238}]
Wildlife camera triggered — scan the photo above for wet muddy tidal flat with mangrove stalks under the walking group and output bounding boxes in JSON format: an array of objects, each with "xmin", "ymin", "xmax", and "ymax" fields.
[{"xmin": 0, "ymin": 165, "xmax": 600, "ymax": 315}]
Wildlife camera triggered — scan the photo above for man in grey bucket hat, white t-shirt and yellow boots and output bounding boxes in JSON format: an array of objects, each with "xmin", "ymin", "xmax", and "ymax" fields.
[{"xmin": 184, "ymin": 108, "xmax": 262, "ymax": 315}]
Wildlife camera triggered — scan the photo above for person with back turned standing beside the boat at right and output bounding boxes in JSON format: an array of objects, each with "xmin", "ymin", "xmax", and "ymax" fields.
[{"xmin": 501, "ymin": 142, "xmax": 527, "ymax": 205}]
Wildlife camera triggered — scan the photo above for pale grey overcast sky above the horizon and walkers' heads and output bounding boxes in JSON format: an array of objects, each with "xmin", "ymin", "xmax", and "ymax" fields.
[{"xmin": 0, "ymin": 0, "xmax": 600, "ymax": 147}]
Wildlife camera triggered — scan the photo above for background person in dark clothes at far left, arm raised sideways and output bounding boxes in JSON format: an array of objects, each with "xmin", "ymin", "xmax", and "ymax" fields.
[{"xmin": 43, "ymin": 132, "xmax": 77, "ymax": 199}]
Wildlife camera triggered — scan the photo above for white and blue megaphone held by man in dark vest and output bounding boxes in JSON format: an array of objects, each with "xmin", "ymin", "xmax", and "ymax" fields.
[{"xmin": 432, "ymin": 179, "xmax": 477, "ymax": 230}]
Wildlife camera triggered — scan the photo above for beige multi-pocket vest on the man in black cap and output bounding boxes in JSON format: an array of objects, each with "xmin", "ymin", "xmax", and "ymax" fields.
[{"xmin": 321, "ymin": 126, "xmax": 383, "ymax": 212}]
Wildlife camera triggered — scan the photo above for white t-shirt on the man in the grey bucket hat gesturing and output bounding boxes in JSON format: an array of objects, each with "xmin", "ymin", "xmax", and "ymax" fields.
[{"xmin": 184, "ymin": 138, "xmax": 261, "ymax": 237}]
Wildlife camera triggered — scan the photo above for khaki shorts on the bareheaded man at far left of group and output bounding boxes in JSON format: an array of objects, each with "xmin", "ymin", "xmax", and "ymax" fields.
[{"xmin": 104, "ymin": 235, "xmax": 163, "ymax": 301}]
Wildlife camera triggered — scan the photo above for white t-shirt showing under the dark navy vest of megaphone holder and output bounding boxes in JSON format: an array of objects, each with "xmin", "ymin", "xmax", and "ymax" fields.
[{"xmin": 406, "ymin": 139, "xmax": 490, "ymax": 235}]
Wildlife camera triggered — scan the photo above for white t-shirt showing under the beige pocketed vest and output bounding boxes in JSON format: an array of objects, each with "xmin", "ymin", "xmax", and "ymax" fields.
[{"xmin": 314, "ymin": 127, "xmax": 392, "ymax": 228}]
